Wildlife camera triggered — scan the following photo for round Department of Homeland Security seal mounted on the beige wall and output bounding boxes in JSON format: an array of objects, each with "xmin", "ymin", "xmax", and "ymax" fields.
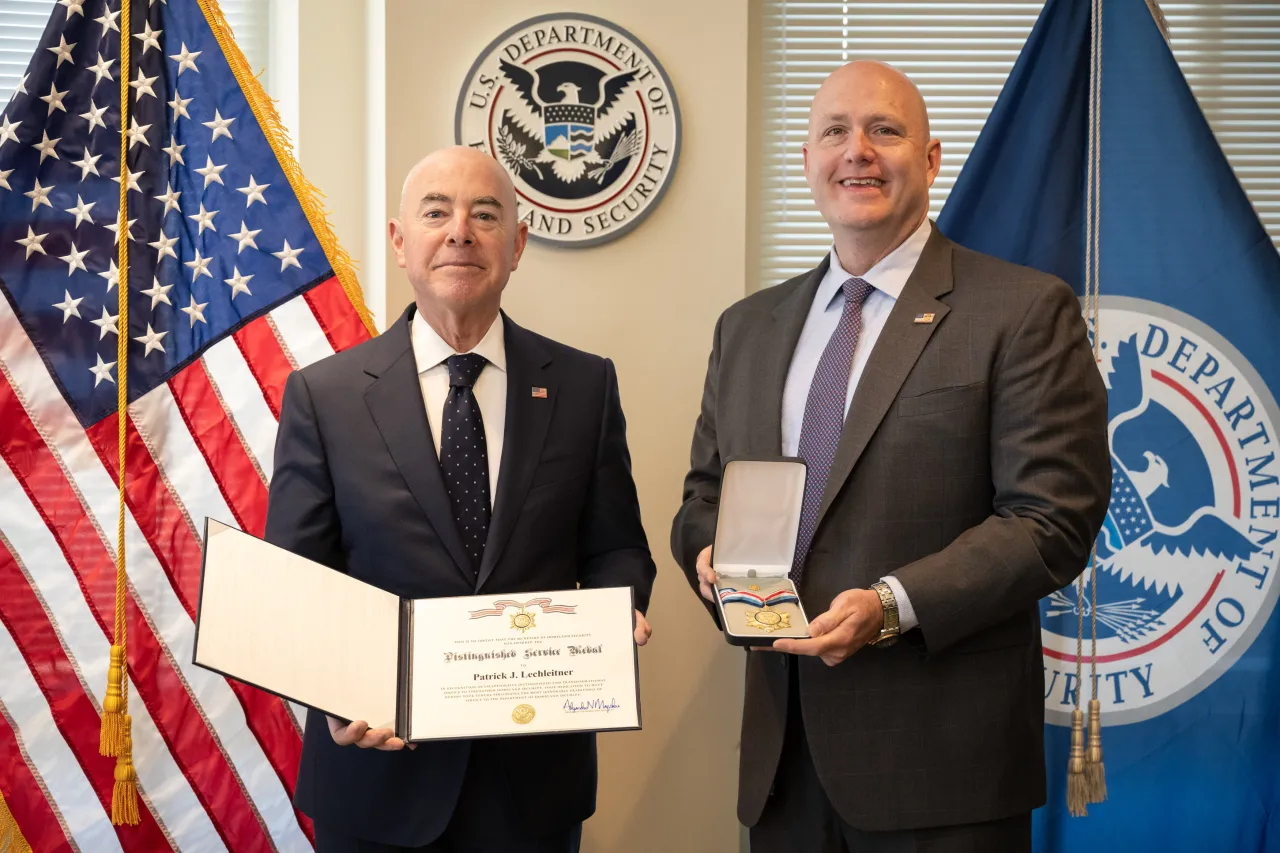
[{"xmin": 454, "ymin": 13, "xmax": 680, "ymax": 247}]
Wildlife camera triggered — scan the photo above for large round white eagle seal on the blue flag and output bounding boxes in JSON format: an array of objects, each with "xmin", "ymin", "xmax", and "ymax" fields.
[{"xmin": 1041, "ymin": 297, "xmax": 1280, "ymax": 725}]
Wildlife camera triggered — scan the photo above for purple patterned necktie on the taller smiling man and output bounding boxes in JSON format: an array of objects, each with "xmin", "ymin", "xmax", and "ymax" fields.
[{"xmin": 791, "ymin": 278, "xmax": 874, "ymax": 584}]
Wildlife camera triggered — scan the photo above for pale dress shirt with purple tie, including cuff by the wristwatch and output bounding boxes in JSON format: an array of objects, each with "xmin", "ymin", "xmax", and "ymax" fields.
[{"xmin": 782, "ymin": 216, "xmax": 933, "ymax": 633}]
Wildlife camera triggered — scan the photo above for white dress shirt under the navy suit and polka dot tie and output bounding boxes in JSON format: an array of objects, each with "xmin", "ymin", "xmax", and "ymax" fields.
[{"xmin": 408, "ymin": 311, "xmax": 507, "ymax": 510}]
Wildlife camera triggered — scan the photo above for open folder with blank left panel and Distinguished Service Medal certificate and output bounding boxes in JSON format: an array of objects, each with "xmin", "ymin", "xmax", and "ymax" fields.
[{"xmin": 193, "ymin": 519, "xmax": 640, "ymax": 742}]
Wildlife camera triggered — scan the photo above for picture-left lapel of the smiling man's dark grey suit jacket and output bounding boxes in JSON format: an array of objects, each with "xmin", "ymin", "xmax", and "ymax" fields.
[{"xmin": 746, "ymin": 258, "xmax": 831, "ymax": 456}]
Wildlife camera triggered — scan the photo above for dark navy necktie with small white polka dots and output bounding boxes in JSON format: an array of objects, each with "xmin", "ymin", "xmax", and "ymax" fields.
[{"xmin": 440, "ymin": 352, "xmax": 489, "ymax": 574}]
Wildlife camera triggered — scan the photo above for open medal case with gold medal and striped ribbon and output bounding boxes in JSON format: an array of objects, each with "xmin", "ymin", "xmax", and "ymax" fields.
[{"xmin": 712, "ymin": 457, "xmax": 809, "ymax": 646}]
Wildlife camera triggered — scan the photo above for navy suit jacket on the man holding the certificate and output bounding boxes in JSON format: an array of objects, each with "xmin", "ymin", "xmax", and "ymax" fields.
[{"xmin": 266, "ymin": 305, "xmax": 655, "ymax": 847}]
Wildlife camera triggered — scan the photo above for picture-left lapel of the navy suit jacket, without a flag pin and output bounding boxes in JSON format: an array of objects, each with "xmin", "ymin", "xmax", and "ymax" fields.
[{"xmin": 365, "ymin": 306, "xmax": 474, "ymax": 583}]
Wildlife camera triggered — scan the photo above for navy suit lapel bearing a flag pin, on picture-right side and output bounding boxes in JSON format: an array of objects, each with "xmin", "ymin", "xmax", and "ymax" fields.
[{"xmin": 473, "ymin": 314, "xmax": 547, "ymax": 592}]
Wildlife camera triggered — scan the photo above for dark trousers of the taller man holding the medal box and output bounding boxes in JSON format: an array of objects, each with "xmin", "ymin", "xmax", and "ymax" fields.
[{"xmin": 751, "ymin": 660, "xmax": 1032, "ymax": 853}]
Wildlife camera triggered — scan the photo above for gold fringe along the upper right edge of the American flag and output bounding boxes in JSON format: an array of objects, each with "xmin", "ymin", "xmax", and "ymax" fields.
[{"xmin": 197, "ymin": 0, "xmax": 378, "ymax": 336}]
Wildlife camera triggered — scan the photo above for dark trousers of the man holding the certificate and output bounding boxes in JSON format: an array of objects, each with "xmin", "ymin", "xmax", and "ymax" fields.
[{"xmin": 316, "ymin": 740, "xmax": 582, "ymax": 853}]
